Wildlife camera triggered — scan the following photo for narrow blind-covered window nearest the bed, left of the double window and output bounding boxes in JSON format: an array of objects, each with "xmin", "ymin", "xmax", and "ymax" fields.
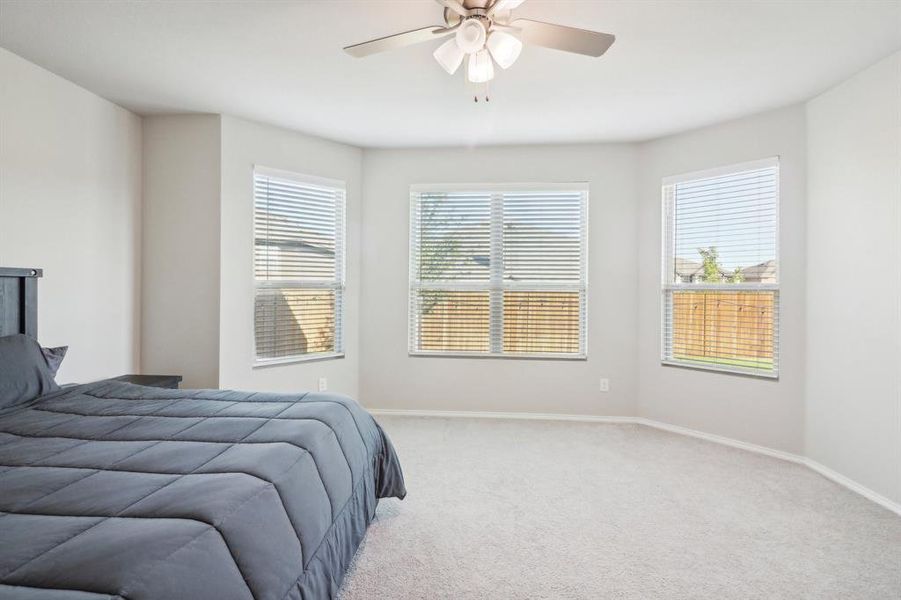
[{"xmin": 253, "ymin": 167, "xmax": 344, "ymax": 364}]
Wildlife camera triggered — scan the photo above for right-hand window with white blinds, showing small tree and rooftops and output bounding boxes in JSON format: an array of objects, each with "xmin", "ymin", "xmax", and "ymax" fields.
[{"xmin": 662, "ymin": 158, "xmax": 779, "ymax": 377}]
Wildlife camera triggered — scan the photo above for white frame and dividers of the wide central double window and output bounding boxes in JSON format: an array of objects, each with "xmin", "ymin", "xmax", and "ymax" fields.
[{"xmin": 407, "ymin": 181, "xmax": 590, "ymax": 361}]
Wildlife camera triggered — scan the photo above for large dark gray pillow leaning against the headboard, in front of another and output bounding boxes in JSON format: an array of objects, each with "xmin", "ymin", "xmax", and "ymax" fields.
[{"xmin": 0, "ymin": 334, "xmax": 59, "ymax": 409}]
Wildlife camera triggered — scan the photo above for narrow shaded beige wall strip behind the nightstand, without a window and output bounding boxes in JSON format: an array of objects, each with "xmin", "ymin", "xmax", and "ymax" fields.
[{"xmin": 141, "ymin": 115, "xmax": 220, "ymax": 387}]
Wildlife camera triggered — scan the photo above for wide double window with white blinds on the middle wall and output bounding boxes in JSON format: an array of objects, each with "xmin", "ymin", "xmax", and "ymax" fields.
[{"xmin": 410, "ymin": 184, "xmax": 588, "ymax": 358}]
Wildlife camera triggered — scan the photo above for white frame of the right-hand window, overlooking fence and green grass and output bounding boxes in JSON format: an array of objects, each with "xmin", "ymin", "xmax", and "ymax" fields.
[{"xmin": 659, "ymin": 155, "xmax": 782, "ymax": 380}]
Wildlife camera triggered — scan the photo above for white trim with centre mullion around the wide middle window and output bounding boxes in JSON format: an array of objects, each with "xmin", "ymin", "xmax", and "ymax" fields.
[{"xmin": 407, "ymin": 181, "xmax": 590, "ymax": 361}]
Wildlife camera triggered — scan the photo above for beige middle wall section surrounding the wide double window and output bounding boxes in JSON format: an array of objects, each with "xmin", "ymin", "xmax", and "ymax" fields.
[{"xmin": 360, "ymin": 145, "xmax": 638, "ymax": 415}]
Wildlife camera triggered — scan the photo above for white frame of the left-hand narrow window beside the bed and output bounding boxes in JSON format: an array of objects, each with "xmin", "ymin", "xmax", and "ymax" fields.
[{"xmin": 250, "ymin": 164, "xmax": 347, "ymax": 369}]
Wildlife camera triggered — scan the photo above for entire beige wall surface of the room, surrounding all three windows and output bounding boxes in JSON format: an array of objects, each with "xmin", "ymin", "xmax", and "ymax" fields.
[{"xmin": 0, "ymin": 50, "xmax": 901, "ymax": 501}]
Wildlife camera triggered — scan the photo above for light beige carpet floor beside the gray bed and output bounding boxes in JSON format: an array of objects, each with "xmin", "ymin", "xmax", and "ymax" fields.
[{"xmin": 341, "ymin": 417, "xmax": 901, "ymax": 600}]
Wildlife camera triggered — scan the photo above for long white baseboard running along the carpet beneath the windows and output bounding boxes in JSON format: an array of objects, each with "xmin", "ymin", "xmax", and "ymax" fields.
[{"xmin": 367, "ymin": 408, "xmax": 901, "ymax": 516}]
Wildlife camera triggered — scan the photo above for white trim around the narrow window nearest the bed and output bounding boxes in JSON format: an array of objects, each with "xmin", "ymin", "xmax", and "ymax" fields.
[{"xmin": 249, "ymin": 164, "xmax": 347, "ymax": 369}]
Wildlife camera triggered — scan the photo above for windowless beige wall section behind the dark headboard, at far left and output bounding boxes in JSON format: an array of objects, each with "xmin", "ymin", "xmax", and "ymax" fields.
[{"xmin": 0, "ymin": 49, "xmax": 141, "ymax": 382}]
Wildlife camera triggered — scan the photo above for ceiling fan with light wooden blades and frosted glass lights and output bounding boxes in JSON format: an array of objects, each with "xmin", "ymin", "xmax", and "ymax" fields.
[{"xmin": 344, "ymin": 0, "xmax": 616, "ymax": 92}]
